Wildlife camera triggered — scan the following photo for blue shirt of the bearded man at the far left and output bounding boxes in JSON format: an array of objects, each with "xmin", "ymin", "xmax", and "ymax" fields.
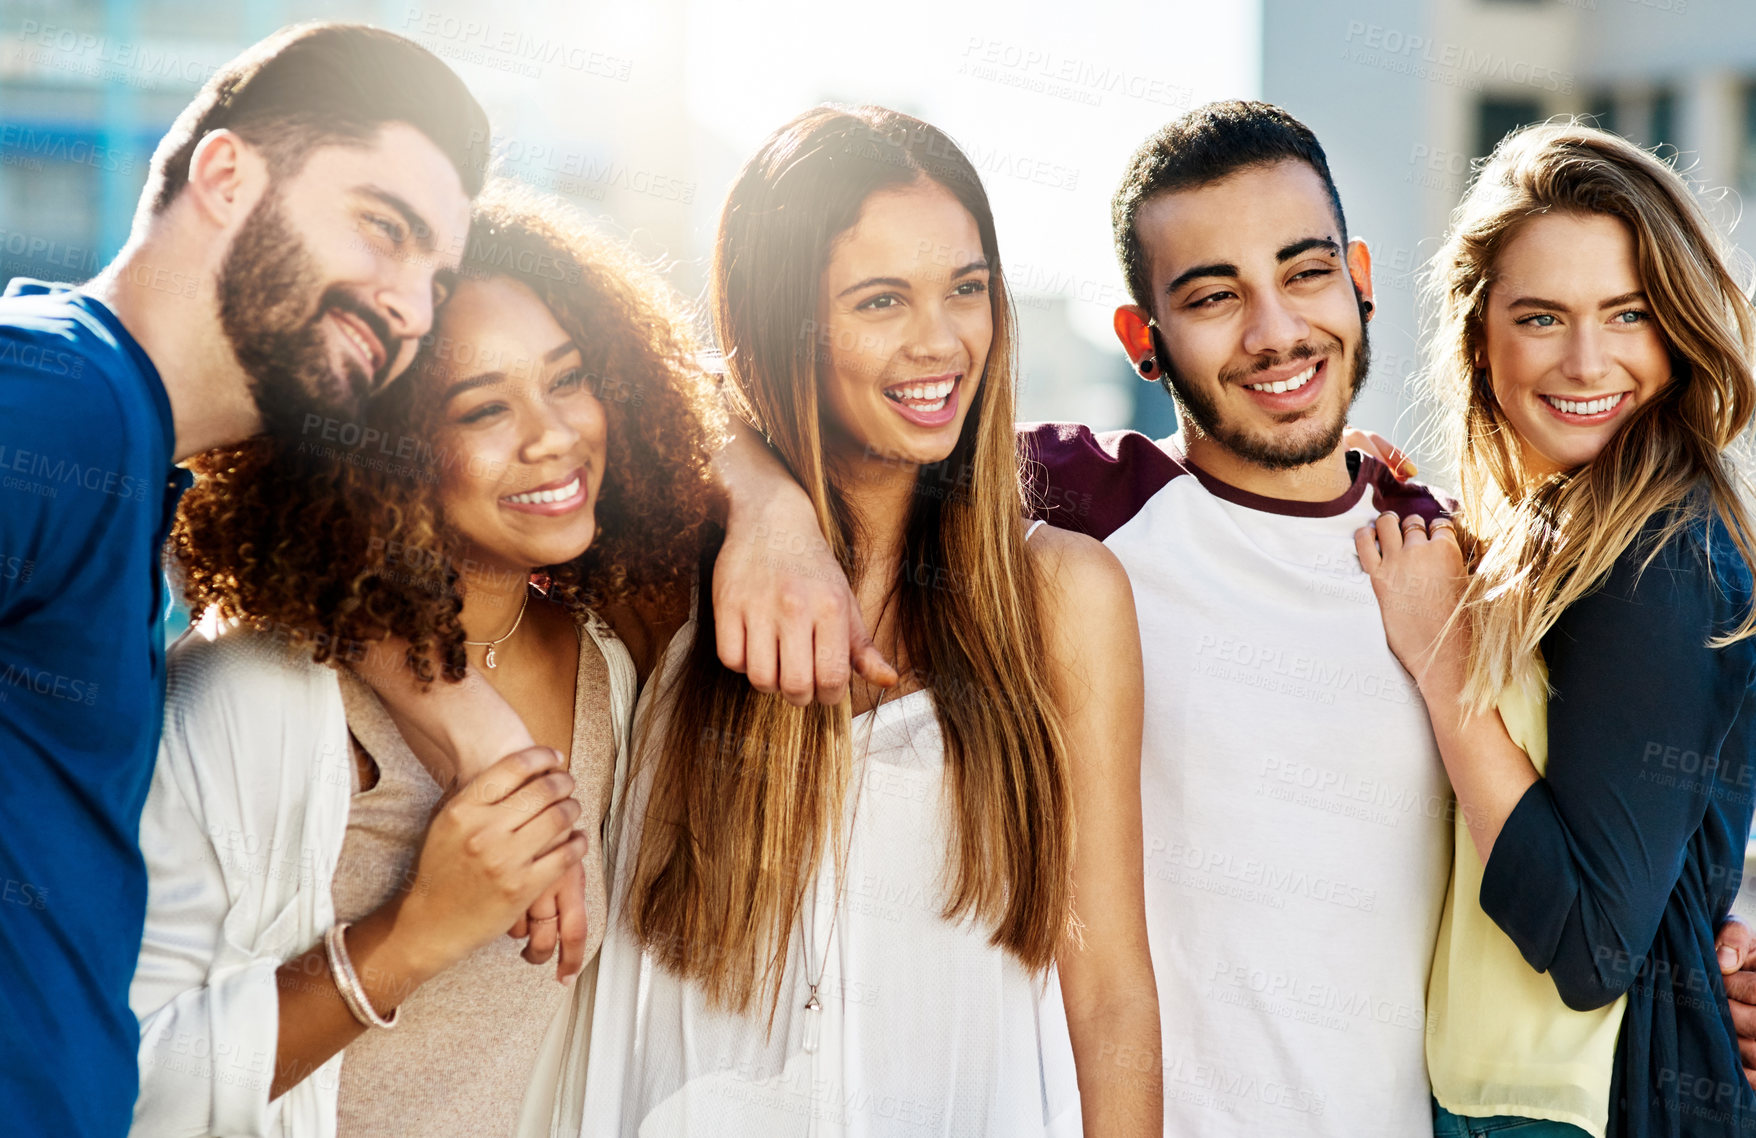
[{"xmin": 0, "ymin": 281, "xmax": 188, "ymax": 1138}]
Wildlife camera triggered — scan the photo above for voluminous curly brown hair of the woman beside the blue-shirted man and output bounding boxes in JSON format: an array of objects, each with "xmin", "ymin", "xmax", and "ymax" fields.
[{"xmin": 172, "ymin": 179, "xmax": 722, "ymax": 681}]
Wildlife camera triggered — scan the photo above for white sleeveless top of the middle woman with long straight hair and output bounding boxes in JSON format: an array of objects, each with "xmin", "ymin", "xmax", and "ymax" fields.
[{"xmin": 585, "ymin": 625, "xmax": 1080, "ymax": 1138}]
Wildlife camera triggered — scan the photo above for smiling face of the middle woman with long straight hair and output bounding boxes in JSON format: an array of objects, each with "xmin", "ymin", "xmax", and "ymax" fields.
[{"xmin": 818, "ymin": 179, "xmax": 994, "ymax": 467}]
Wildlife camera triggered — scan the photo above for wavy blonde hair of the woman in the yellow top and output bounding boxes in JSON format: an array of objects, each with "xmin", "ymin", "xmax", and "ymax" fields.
[{"xmin": 1426, "ymin": 121, "xmax": 1756, "ymax": 709}]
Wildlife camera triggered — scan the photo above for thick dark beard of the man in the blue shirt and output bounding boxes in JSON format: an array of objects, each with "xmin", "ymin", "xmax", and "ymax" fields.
[{"xmin": 218, "ymin": 191, "xmax": 400, "ymax": 437}]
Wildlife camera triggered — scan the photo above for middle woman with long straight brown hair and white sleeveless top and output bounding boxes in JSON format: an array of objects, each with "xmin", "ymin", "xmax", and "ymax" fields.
[{"xmin": 587, "ymin": 107, "xmax": 1162, "ymax": 1138}]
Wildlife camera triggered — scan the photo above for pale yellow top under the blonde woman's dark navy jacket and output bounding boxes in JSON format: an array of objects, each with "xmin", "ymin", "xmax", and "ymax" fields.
[{"xmin": 1426, "ymin": 659, "xmax": 1628, "ymax": 1138}]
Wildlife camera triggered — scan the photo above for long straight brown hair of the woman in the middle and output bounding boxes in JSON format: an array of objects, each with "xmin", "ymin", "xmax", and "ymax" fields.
[{"xmin": 627, "ymin": 107, "xmax": 1075, "ymax": 1012}]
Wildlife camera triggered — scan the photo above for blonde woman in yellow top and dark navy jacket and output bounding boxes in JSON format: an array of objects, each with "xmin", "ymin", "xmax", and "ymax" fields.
[{"xmin": 1359, "ymin": 125, "xmax": 1756, "ymax": 1136}]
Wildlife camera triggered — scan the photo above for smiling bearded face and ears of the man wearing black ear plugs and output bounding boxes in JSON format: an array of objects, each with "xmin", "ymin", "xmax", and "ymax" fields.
[{"xmin": 1117, "ymin": 160, "xmax": 1371, "ymax": 497}]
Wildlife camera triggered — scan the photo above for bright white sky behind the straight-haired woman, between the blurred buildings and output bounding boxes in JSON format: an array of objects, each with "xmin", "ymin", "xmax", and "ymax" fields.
[{"xmin": 685, "ymin": 0, "xmax": 1261, "ymax": 349}]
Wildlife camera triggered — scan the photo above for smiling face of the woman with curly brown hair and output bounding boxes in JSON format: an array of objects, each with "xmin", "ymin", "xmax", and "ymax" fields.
[{"xmin": 426, "ymin": 277, "xmax": 608, "ymax": 574}]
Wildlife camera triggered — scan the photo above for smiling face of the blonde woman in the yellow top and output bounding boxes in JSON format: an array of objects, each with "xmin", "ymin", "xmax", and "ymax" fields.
[{"xmin": 1477, "ymin": 212, "xmax": 1672, "ymax": 476}]
